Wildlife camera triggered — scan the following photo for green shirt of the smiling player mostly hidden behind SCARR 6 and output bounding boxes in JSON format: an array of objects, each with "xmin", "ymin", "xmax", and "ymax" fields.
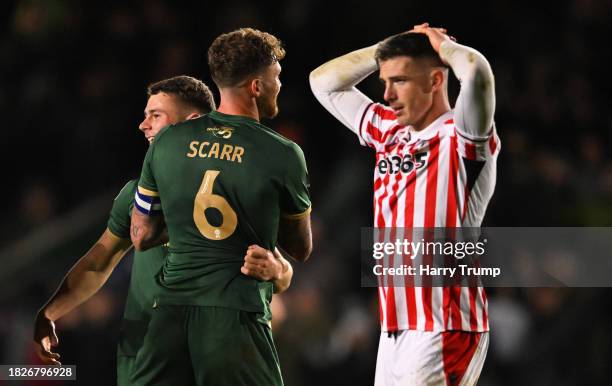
[{"xmin": 108, "ymin": 180, "xmax": 166, "ymax": 356}]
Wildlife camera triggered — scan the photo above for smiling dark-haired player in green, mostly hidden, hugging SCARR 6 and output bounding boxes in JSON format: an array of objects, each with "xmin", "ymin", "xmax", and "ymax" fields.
[{"xmin": 34, "ymin": 76, "xmax": 293, "ymax": 385}]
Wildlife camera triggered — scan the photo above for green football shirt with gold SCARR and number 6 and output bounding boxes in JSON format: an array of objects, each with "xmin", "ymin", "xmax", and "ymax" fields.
[{"xmin": 136, "ymin": 111, "xmax": 310, "ymax": 314}]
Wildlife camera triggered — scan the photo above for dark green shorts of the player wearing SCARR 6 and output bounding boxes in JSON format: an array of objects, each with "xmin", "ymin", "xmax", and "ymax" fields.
[{"xmin": 128, "ymin": 306, "xmax": 283, "ymax": 386}]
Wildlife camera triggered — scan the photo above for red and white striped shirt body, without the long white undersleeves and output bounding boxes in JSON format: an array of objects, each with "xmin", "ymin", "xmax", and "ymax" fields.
[{"xmin": 354, "ymin": 103, "xmax": 500, "ymax": 332}]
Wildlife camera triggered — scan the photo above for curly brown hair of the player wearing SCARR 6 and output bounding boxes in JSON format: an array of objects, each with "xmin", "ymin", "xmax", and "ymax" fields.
[{"xmin": 208, "ymin": 28, "xmax": 285, "ymax": 87}]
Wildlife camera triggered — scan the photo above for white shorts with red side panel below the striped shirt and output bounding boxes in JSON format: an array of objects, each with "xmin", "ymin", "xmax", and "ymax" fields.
[{"xmin": 374, "ymin": 330, "xmax": 489, "ymax": 386}]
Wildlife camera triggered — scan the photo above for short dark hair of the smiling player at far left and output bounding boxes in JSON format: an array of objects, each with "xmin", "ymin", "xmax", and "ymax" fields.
[{"xmin": 147, "ymin": 75, "xmax": 216, "ymax": 114}]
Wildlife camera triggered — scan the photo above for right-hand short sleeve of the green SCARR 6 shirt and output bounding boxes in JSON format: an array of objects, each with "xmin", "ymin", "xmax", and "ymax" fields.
[{"xmin": 280, "ymin": 143, "xmax": 311, "ymax": 217}]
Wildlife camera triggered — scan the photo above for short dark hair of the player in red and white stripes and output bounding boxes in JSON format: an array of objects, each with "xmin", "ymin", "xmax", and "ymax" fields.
[{"xmin": 375, "ymin": 32, "xmax": 446, "ymax": 67}]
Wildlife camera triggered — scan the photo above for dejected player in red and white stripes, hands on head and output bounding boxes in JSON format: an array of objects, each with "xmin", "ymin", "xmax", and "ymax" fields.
[{"xmin": 310, "ymin": 23, "xmax": 500, "ymax": 386}]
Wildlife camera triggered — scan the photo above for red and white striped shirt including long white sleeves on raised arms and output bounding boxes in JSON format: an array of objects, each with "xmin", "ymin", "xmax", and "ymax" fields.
[{"xmin": 310, "ymin": 39, "xmax": 500, "ymax": 332}]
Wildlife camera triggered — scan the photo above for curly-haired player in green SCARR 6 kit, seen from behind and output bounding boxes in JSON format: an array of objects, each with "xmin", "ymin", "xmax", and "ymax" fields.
[{"xmin": 131, "ymin": 28, "xmax": 312, "ymax": 386}]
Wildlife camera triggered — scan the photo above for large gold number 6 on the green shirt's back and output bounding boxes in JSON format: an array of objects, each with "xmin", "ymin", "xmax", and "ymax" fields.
[{"xmin": 193, "ymin": 170, "xmax": 238, "ymax": 240}]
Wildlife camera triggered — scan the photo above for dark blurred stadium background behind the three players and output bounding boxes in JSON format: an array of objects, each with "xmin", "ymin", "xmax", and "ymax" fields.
[{"xmin": 0, "ymin": 0, "xmax": 612, "ymax": 386}]
